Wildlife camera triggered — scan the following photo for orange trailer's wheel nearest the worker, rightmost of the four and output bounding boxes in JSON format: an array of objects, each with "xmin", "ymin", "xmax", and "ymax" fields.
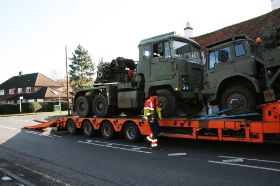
[{"xmin": 123, "ymin": 122, "xmax": 141, "ymax": 142}]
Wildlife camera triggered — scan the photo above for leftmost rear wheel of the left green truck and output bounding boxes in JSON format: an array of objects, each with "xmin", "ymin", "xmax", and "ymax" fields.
[{"xmin": 76, "ymin": 96, "xmax": 92, "ymax": 118}]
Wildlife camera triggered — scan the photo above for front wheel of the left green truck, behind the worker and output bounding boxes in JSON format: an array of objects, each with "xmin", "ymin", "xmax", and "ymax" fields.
[{"xmin": 157, "ymin": 89, "xmax": 176, "ymax": 117}]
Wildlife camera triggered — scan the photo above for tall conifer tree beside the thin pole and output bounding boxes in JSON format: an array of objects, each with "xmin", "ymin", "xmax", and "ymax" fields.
[{"xmin": 69, "ymin": 45, "xmax": 95, "ymax": 92}]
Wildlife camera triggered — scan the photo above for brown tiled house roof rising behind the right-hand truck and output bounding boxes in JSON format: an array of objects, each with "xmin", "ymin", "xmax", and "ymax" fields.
[{"xmin": 193, "ymin": 8, "xmax": 280, "ymax": 48}]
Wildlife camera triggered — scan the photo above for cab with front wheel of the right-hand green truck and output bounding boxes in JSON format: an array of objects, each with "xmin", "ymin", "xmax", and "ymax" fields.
[{"xmin": 204, "ymin": 35, "xmax": 266, "ymax": 114}]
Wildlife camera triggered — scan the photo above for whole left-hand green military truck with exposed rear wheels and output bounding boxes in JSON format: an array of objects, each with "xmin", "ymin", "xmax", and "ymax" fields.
[{"xmin": 74, "ymin": 32, "xmax": 203, "ymax": 117}]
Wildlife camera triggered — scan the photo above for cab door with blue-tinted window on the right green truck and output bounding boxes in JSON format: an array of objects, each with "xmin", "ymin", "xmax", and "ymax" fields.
[{"xmin": 204, "ymin": 46, "xmax": 235, "ymax": 94}]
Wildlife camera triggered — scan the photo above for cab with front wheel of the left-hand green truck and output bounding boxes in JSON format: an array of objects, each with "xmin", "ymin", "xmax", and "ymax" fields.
[{"xmin": 137, "ymin": 32, "xmax": 203, "ymax": 116}]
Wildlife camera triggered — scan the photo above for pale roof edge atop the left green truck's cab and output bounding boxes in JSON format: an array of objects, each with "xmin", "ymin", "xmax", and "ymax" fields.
[{"xmin": 139, "ymin": 32, "xmax": 200, "ymax": 48}]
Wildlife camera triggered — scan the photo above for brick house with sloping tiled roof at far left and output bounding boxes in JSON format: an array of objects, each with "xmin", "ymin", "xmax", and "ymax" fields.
[{"xmin": 0, "ymin": 72, "xmax": 67, "ymax": 103}]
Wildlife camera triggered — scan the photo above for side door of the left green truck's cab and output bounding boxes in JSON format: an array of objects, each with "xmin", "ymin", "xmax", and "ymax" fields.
[{"xmin": 150, "ymin": 41, "xmax": 174, "ymax": 82}]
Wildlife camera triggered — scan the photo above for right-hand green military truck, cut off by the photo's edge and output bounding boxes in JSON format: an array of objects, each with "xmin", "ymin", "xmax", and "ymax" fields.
[{"xmin": 204, "ymin": 28, "xmax": 280, "ymax": 114}]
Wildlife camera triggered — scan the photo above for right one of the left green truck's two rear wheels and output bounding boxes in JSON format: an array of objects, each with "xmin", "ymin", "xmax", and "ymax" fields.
[{"xmin": 92, "ymin": 94, "xmax": 109, "ymax": 118}]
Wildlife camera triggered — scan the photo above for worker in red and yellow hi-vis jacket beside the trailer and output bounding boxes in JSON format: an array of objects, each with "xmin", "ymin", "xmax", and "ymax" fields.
[{"xmin": 144, "ymin": 95, "xmax": 162, "ymax": 148}]
